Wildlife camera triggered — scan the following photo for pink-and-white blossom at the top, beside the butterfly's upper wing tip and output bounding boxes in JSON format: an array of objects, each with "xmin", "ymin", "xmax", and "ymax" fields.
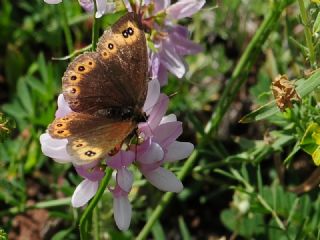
[{"xmin": 124, "ymin": 0, "xmax": 205, "ymax": 86}]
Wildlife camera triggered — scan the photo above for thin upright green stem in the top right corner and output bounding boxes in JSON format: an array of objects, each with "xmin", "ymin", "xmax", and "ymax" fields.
[{"xmin": 298, "ymin": 0, "xmax": 317, "ymax": 68}]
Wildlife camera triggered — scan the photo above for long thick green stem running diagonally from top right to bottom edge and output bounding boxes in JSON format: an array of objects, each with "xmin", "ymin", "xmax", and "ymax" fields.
[{"xmin": 136, "ymin": 0, "xmax": 293, "ymax": 240}]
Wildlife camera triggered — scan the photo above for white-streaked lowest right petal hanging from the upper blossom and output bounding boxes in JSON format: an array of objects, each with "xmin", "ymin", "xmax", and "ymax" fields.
[{"xmin": 159, "ymin": 39, "xmax": 186, "ymax": 78}]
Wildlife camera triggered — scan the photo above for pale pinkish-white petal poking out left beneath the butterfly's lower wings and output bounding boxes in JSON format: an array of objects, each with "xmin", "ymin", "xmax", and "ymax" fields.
[{"xmin": 40, "ymin": 133, "xmax": 73, "ymax": 163}]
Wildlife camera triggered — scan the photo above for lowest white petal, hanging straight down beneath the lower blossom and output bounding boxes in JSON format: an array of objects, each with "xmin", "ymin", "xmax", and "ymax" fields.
[{"xmin": 113, "ymin": 196, "xmax": 132, "ymax": 231}]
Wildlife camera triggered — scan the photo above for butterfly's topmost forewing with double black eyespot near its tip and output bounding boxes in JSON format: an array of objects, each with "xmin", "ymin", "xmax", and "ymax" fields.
[{"xmin": 97, "ymin": 13, "xmax": 148, "ymax": 107}]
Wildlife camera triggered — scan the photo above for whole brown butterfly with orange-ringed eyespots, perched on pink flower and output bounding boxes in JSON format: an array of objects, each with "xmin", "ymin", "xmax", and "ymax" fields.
[{"xmin": 48, "ymin": 13, "xmax": 148, "ymax": 164}]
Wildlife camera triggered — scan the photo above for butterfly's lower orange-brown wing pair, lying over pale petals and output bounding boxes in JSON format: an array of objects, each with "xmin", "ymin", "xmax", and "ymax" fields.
[{"xmin": 48, "ymin": 113, "xmax": 135, "ymax": 165}]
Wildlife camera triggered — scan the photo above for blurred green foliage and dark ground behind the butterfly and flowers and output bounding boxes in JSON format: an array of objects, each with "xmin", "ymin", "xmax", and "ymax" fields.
[{"xmin": 0, "ymin": 0, "xmax": 320, "ymax": 240}]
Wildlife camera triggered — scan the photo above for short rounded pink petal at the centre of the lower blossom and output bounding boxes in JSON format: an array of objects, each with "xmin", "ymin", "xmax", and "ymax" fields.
[{"xmin": 137, "ymin": 142, "xmax": 164, "ymax": 164}]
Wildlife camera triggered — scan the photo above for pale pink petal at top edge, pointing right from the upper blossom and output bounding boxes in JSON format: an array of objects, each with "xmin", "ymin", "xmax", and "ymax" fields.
[{"xmin": 166, "ymin": 0, "xmax": 206, "ymax": 19}]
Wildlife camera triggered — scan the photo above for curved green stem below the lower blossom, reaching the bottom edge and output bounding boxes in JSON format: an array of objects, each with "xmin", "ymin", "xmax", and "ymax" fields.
[{"xmin": 79, "ymin": 168, "xmax": 112, "ymax": 240}]
